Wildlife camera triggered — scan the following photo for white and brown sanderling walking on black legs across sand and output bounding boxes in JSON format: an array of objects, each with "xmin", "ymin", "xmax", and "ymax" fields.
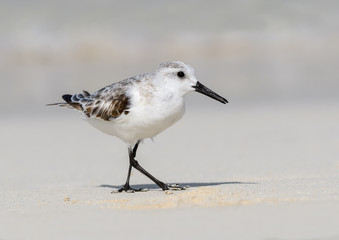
[{"xmin": 49, "ymin": 61, "xmax": 227, "ymax": 192}]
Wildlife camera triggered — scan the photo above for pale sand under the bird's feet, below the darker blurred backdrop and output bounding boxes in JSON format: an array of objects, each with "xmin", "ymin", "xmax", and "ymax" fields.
[{"xmin": 0, "ymin": 102, "xmax": 339, "ymax": 240}]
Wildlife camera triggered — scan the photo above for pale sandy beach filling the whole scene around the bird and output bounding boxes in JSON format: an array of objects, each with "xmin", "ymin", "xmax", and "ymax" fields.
[{"xmin": 0, "ymin": 0, "xmax": 339, "ymax": 240}]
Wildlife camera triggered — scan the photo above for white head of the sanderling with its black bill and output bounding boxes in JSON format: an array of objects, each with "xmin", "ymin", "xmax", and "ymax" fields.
[{"xmin": 155, "ymin": 61, "xmax": 227, "ymax": 103}]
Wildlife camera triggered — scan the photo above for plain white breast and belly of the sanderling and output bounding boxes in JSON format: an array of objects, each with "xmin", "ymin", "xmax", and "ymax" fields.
[{"xmin": 88, "ymin": 81, "xmax": 185, "ymax": 145}]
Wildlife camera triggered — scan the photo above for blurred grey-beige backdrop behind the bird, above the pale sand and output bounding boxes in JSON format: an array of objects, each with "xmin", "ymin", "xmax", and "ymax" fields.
[{"xmin": 0, "ymin": 0, "xmax": 339, "ymax": 112}]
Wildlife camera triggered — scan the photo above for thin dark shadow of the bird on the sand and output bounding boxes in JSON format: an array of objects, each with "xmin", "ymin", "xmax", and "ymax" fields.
[{"xmin": 98, "ymin": 182, "xmax": 257, "ymax": 189}]
